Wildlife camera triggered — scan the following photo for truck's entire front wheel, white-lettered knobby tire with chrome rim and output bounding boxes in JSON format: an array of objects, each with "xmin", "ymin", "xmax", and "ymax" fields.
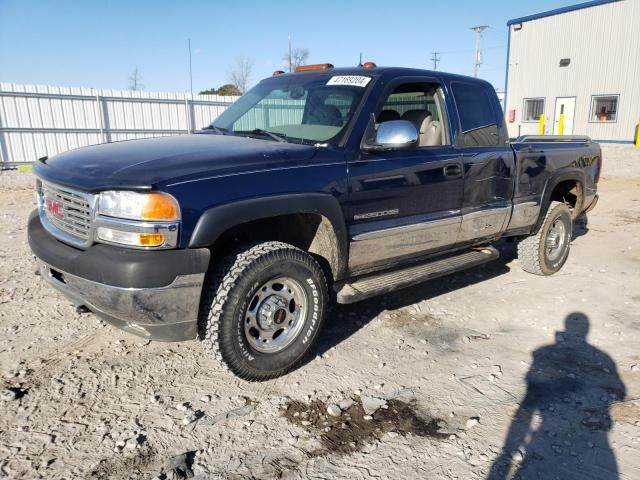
[{"xmin": 198, "ymin": 242, "xmax": 328, "ymax": 381}]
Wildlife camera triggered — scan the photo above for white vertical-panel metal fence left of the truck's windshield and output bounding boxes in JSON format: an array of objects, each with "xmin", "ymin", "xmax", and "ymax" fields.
[{"xmin": 0, "ymin": 83, "xmax": 237, "ymax": 166}]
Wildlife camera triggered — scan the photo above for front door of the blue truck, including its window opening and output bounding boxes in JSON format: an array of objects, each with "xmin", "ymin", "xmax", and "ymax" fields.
[{"xmin": 346, "ymin": 77, "xmax": 463, "ymax": 273}]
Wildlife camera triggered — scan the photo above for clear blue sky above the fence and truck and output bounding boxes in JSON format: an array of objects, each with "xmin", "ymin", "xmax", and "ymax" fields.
[{"xmin": 0, "ymin": 0, "xmax": 578, "ymax": 93}]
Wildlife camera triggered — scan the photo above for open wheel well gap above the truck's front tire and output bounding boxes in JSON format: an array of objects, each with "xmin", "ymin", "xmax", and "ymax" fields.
[{"xmin": 211, "ymin": 213, "xmax": 340, "ymax": 281}]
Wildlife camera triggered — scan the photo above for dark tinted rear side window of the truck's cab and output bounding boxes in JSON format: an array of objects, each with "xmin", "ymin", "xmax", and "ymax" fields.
[{"xmin": 451, "ymin": 82, "xmax": 499, "ymax": 147}]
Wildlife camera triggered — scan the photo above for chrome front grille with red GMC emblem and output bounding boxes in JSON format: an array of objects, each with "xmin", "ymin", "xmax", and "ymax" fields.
[{"xmin": 41, "ymin": 182, "xmax": 91, "ymax": 243}]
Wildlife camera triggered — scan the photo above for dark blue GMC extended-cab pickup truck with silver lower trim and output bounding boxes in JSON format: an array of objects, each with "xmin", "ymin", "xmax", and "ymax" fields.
[{"xmin": 28, "ymin": 64, "xmax": 602, "ymax": 380}]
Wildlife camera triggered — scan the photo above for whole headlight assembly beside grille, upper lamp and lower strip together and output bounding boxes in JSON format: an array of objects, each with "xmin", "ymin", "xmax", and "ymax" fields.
[{"xmin": 96, "ymin": 190, "xmax": 180, "ymax": 248}]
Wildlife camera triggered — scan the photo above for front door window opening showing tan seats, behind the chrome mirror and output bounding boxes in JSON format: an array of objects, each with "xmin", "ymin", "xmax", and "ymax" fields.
[{"xmin": 376, "ymin": 83, "xmax": 447, "ymax": 147}]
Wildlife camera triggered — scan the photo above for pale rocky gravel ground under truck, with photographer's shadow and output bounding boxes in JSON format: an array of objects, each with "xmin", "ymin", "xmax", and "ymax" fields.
[{"xmin": 0, "ymin": 148, "xmax": 640, "ymax": 479}]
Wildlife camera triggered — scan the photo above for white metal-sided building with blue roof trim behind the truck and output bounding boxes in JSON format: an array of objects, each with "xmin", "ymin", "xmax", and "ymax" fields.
[{"xmin": 505, "ymin": 0, "xmax": 640, "ymax": 143}]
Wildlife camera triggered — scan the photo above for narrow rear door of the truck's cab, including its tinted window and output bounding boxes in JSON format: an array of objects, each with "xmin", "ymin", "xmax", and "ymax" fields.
[{"xmin": 450, "ymin": 81, "xmax": 515, "ymax": 244}]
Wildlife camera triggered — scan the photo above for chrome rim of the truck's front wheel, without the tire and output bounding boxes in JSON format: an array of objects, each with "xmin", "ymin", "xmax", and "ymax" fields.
[{"xmin": 244, "ymin": 277, "xmax": 308, "ymax": 353}]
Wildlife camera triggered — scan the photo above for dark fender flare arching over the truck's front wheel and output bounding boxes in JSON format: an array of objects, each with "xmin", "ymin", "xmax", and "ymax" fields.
[{"xmin": 189, "ymin": 193, "xmax": 348, "ymax": 278}]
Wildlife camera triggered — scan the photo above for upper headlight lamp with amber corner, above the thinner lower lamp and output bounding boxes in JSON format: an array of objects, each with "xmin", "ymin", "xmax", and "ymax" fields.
[{"xmin": 98, "ymin": 190, "xmax": 180, "ymax": 221}]
